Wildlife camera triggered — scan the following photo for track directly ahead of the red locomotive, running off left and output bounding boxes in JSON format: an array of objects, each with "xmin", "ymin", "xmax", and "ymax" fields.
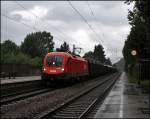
[{"xmin": 0, "ymin": 88, "xmax": 54, "ymax": 105}]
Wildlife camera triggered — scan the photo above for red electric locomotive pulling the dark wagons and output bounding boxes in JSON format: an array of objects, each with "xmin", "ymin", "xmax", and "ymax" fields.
[{"xmin": 42, "ymin": 52, "xmax": 89, "ymax": 82}]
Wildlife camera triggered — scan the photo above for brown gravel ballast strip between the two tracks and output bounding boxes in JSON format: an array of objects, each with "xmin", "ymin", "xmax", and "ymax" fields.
[{"xmin": 1, "ymin": 74, "xmax": 114, "ymax": 119}]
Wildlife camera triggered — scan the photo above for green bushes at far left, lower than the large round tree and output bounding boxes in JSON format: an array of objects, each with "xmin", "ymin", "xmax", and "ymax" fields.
[{"xmin": 0, "ymin": 40, "xmax": 42, "ymax": 67}]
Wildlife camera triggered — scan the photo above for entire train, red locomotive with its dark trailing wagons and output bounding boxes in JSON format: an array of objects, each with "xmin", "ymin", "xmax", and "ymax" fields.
[{"xmin": 41, "ymin": 52, "xmax": 117, "ymax": 83}]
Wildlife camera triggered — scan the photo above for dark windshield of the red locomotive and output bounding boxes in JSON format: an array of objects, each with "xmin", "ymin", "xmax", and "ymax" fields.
[{"xmin": 47, "ymin": 56, "xmax": 63, "ymax": 67}]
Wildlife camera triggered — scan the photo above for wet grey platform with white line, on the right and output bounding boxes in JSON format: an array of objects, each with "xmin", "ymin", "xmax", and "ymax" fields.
[{"xmin": 94, "ymin": 72, "xmax": 150, "ymax": 119}]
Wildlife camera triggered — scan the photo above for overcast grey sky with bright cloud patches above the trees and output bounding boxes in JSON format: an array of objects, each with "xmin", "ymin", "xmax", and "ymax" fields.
[{"xmin": 1, "ymin": 1, "xmax": 133, "ymax": 63}]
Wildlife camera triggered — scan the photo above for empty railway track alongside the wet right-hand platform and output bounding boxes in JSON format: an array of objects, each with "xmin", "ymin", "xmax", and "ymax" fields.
[{"xmin": 40, "ymin": 74, "xmax": 120, "ymax": 119}]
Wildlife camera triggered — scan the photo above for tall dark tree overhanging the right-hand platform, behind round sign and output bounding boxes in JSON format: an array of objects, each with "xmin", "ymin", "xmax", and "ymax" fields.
[{"xmin": 123, "ymin": 0, "xmax": 150, "ymax": 70}]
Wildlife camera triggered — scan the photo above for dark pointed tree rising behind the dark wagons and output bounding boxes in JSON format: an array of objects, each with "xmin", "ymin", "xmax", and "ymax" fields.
[{"xmin": 93, "ymin": 44, "xmax": 106, "ymax": 63}]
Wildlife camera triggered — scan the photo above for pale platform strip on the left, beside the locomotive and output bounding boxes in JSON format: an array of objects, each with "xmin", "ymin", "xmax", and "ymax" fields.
[{"xmin": 0, "ymin": 76, "xmax": 41, "ymax": 85}]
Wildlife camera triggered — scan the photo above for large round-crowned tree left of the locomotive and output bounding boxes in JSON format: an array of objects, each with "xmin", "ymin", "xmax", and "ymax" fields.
[{"xmin": 21, "ymin": 31, "xmax": 54, "ymax": 58}]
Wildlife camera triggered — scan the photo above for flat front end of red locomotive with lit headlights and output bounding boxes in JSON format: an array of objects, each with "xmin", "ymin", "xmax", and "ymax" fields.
[{"xmin": 42, "ymin": 52, "xmax": 65, "ymax": 82}]
